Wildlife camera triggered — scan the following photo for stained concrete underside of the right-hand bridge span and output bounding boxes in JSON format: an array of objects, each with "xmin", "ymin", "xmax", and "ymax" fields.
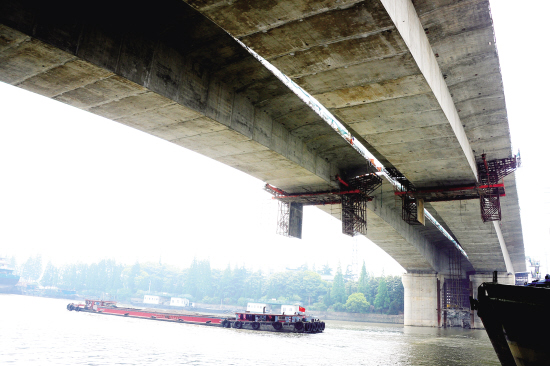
[{"xmin": 187, "ymin": 0, "xmax": 525, "ymax": 271}]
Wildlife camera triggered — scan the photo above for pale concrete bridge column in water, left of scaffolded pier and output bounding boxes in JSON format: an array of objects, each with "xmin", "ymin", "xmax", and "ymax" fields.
[{"xmin": 401, "ymin": 273, "xmax": 443, "ymax": 327}]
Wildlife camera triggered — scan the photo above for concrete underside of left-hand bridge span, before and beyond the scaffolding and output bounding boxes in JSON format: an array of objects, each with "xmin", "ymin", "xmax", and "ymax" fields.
[{"xmin": 0, "ymin": 0, "xmax": 468, "ymax": 272}]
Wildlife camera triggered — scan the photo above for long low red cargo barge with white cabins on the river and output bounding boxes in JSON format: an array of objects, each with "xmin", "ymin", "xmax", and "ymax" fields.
[{"xmin": 67, "ymin": 300, "xmax": 325, "ymax": 333}]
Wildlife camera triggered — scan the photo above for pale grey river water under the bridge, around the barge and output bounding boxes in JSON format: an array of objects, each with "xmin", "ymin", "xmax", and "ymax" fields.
[{"xmin": 0, "ymin": 294, "xmax": 500, "ymax": 366}]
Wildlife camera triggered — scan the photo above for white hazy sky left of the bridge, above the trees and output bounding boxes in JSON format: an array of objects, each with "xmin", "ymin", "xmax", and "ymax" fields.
[{"xmin": 0, "ymin": 79, "xmax": 403, "ymax": 274}]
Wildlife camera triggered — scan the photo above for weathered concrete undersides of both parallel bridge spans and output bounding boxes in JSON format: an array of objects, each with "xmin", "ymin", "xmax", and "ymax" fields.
[{"xmin": 0, "ymin": 0, "xmax": 525, "ymax": 325}]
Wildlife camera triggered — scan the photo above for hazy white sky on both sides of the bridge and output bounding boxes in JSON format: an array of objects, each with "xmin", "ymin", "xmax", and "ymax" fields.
[{"xmin": 0, "ymin": 0, "xmax": 550, "ymax": 274}]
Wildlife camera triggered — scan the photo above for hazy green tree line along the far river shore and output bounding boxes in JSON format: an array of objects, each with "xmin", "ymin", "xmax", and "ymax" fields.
[{"xmin": 11, "ymin": 256, "xmax": 404, "ymax": 314}]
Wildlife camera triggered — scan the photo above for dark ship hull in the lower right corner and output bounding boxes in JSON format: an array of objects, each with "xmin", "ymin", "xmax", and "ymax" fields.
[{"xmin": 472, "ymin": 283, "xmax": 550, "ymax": 366}]
